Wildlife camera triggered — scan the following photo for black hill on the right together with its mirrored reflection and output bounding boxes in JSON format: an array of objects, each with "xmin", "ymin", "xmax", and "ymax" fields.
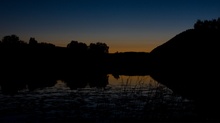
[{"xmin": 150, "ymin": 19, "xmax": 220, "ymax": 118}]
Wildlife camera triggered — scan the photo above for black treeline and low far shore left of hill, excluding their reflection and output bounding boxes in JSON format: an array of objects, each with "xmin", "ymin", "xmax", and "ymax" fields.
[{"xmin": 0, "ymin": 35, "xmax": 148, "ymax": 77}]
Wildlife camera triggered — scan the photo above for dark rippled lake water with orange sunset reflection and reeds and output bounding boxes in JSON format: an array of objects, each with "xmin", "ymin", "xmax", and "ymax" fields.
[{"xmin": 0, "ymin": 76, "xmax": 197, "ymax": 123}]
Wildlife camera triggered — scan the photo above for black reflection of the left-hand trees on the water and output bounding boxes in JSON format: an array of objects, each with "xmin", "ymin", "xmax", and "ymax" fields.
[{"xmin": 0, "ymin": 72, "xmax": 109, "ymax": 95}]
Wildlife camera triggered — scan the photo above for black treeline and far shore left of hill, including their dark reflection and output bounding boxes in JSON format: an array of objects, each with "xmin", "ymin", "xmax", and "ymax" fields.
[{"xmin": 0, "ymin": 35, "xmax": 149, "ymax": 93}]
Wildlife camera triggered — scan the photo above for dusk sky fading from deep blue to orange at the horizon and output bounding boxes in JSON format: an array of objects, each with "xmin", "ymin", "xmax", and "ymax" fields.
[{"xmin": 0, "ymin": 0, "xmax": 220, "ymax": 52}]
